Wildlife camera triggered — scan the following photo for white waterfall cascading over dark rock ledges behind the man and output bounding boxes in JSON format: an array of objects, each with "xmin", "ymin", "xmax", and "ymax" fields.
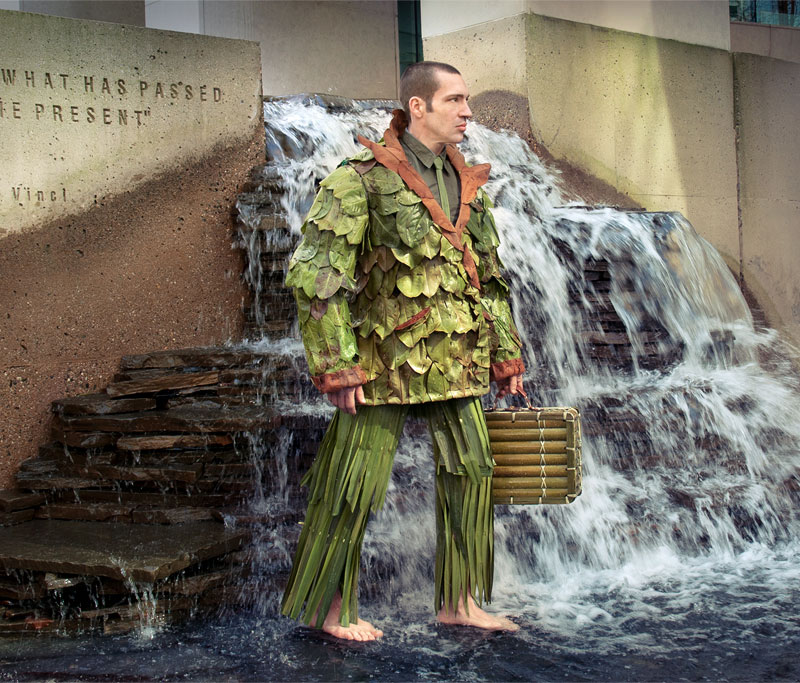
[{"xmin": 251, "ymin": 98, "xmax": 800, "ymax": 653}]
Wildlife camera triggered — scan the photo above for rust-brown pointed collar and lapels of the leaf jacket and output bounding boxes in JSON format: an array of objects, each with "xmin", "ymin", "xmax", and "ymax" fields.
[{"xmin": 358, "ymin": 109, "xmax": 491, "ymax": 289}]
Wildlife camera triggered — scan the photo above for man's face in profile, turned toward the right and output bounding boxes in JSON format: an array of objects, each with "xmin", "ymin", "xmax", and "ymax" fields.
[{"xmin": 416, "ymin": 71, "xmax": 472, "ymax": 147}]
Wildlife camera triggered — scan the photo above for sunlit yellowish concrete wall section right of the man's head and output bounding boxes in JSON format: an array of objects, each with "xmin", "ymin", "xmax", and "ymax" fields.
[{"xmin": 527, "ymin": 15, "xmax": 739, "ymax": 270}]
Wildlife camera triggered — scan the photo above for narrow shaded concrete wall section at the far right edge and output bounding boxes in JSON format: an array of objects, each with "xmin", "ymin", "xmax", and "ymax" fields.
[{"xmin": 735, "ymin": 54, "xmax": 800, "ymax": 343}]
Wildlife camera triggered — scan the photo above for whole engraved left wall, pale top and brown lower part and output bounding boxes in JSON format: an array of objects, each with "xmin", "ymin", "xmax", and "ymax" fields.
[{"xmin": 0, "ymin": 12, "xmax": 264, "ymax": 488}]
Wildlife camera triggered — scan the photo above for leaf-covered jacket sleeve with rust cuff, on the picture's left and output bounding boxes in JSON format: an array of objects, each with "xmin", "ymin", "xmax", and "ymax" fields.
[{"xmin": 286, "ymin": 166, "xmax": 369, "ymax": 393}]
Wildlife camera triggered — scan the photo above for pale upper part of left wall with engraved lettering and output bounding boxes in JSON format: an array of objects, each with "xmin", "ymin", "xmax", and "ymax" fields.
[{"xmin": 0, "ymin": 11, "xmax": 261, "ymax": 236}]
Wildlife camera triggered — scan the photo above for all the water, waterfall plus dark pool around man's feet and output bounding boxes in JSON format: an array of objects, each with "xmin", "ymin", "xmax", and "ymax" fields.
[{"xmin": 0, "ymin": 100, "xmax": 800, "ymax": 681}]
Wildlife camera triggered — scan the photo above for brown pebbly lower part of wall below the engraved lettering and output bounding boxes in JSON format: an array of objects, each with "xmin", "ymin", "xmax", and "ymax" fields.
[{"xmin": 0, "ymin": 131, "xmax": 263, "ymax": 488}]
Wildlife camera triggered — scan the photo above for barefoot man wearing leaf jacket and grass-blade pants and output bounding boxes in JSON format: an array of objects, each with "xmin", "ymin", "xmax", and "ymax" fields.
[{"xmin": 282, "ymin": 62, "xmax": 524, "ymax": 640}]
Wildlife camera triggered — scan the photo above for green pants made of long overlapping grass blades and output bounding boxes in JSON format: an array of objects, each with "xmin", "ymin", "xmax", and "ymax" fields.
[{"xmin": 282, "ymin": 398, "xmax": 494, "ymax": 628}]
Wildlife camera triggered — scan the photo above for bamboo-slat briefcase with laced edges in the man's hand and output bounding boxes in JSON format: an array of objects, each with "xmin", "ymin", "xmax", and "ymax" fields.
[{"xmin": 486, "ymin": 399, "xmax": 581, "ymax": 505}]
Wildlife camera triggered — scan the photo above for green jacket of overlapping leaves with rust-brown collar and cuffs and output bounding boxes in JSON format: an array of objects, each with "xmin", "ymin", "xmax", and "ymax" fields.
[{"xmin": 286, "ymin": 117, "xmax": 524, "ymax": 405}]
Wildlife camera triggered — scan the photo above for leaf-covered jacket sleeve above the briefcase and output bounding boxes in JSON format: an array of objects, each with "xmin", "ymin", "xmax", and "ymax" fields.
[{"xmin": 468, "ymin": 190, "xmax": 525, "ymax": 381}]
